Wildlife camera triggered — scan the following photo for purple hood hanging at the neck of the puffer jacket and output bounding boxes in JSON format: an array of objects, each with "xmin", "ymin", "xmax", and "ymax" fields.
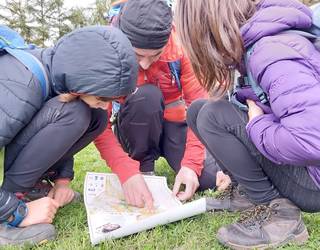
[{"xmin": 241, "ymin": 0, "xmax": 312, "ymax": 47}]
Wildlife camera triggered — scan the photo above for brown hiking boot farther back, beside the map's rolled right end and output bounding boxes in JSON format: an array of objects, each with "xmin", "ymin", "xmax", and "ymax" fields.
[{"xmin": 206, "ymin": 185, "xmax": 254, "ymax": 212}]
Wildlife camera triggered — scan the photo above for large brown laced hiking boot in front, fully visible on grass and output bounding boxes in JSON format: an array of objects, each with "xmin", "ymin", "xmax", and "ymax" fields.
[{"xmin": 217, "ymin": 198, "xmax": 309, "ymax": 250}]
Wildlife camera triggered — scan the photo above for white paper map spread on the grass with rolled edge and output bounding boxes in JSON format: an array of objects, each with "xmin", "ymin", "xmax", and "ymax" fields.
[{"xmin": 84, "ymin": 173, "xmax": 206, "ymax": 245}]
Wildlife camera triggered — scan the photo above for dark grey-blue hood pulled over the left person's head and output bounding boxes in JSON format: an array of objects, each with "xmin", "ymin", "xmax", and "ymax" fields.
[{"xmin": 47, "ymin": 26, "xmax": 138, "ymax": 97}]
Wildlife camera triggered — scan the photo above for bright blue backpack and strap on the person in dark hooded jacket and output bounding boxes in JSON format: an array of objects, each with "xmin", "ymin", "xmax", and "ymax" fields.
[{"xmin": 0, "ymin": 25, "xmax": 49, "ymax": 101}]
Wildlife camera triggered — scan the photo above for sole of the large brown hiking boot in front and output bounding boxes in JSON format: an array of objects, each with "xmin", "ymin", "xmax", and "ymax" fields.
[{"xmin": 219, "ymin": 228, "xmax": 309, "ymax": 250}]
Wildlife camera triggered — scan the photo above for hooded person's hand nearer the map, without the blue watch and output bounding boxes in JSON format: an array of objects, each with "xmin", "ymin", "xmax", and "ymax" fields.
[{"xmin": 48, "ymin": 180, "xmax": 74, "ymax": 207}]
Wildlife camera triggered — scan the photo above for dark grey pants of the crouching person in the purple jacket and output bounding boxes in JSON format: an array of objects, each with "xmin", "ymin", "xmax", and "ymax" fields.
[{"xmin": 188, "ymin": 100, "xmax": 320, "ymax": 212}]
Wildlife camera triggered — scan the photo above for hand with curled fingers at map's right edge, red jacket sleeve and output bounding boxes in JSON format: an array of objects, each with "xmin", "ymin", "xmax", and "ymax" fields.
[{"xmin": 172, "ymin": 167, "xmax": 199, "ymax": 201}]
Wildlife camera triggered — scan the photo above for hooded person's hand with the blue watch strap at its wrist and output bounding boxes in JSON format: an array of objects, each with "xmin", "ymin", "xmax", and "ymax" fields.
[{"xmin": 19, "ymin": 197, "xmax": 59, "ymax": 227}]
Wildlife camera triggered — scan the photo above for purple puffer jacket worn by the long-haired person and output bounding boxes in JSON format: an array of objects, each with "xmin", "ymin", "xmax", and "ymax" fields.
[{"xmin": 241, "ymin": 0, "xmax": 320, "ymax": 187}]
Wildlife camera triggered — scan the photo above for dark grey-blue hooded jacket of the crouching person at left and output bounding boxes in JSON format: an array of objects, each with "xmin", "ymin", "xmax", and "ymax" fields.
[{"xmin": 0, "ymin": 26, "xmax": 138, "ymax": 223}]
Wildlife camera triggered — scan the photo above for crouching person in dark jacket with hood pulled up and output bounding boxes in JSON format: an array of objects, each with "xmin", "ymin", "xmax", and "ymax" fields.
[{"xmin": 0, "ymin": 26, "xmax": 138, "ymax": 246}]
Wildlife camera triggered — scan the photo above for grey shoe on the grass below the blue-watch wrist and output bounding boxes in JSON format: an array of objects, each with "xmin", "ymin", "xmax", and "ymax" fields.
[{"xmin": 0, "ymin": 224, "xmax": 56, "ymax": 247}]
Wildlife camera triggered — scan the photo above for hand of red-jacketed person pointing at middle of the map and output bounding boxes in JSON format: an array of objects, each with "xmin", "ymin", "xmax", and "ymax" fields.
[{"xmin": 122, "ymin": 174, "xmax": 153, "ymax": 210}]
